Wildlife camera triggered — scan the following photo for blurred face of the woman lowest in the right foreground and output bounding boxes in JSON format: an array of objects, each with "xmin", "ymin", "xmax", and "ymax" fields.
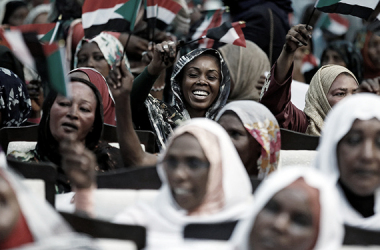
[{"xmin": 250, "ymin": 187, "xmax": 318, "ymax": 250}]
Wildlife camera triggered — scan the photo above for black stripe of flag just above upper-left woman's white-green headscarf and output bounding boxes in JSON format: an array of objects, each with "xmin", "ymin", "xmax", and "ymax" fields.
[{"xmin": 84, "ymin": 18, "xmax": 130, "ymax": 38}]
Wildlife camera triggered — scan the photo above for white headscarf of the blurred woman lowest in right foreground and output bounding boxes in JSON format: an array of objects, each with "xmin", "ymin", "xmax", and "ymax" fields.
[{"xmin": 231, "ymin": 167, "xmax": 344, "ymax": 250}]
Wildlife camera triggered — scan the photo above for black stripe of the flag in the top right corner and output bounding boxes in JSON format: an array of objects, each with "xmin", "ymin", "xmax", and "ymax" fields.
[{"xmin": 317, "ymin": 3, "xmax": 373, "ymax": 20}]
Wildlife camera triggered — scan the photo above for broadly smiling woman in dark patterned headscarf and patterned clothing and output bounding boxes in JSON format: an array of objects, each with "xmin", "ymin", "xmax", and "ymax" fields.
[{"xmin": 145, "ymin": 49, "xmax": 230, "ymax": 148}]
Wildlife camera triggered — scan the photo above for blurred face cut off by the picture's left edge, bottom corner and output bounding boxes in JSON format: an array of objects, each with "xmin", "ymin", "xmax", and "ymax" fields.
[{"xmin": 0, "ymin": 175, "xmax": 20, "ymax": 243}]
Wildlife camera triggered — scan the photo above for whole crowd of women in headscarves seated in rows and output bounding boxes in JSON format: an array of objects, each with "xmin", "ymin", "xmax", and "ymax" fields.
[{"xmin": 0, "ymin": 0, "xmax": 380, "ymax": 250}]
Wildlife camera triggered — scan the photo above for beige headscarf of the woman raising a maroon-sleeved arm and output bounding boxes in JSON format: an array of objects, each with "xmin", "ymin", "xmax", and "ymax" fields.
[{"xmin": 304, "ymin": 65, "xmax": 359, "ymax": 136}]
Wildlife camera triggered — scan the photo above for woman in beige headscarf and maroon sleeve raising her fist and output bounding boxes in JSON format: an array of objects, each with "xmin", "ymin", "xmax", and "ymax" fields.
[{"xmin": 260, "ymin": 24, "xmax": 359, "ymax": 136}]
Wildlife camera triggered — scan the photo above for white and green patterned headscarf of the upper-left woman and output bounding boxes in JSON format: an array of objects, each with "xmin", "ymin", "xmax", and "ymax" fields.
[{"xmin": 74, "ymin": 32, "xmax": 129, "ymax": 72}]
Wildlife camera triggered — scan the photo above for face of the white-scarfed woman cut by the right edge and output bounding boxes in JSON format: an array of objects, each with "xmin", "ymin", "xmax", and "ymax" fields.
[{"xmin": 337, "ymin": 118, "xmax": 380, "ymax": 196}]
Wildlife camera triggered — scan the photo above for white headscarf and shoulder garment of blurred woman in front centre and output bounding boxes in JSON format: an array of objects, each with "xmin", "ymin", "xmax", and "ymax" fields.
[{"xmin": 114, "ymin": 118, "xmax": 252, "ymax": 249}]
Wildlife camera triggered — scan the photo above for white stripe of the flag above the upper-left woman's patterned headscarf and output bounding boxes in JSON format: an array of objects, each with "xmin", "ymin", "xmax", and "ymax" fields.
[{"xmin": 82, "ymin": 3, "xmax": 124, "ymax": 29}]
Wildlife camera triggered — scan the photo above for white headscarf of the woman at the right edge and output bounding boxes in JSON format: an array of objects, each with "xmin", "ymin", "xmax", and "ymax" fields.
[{"xmin": 315, "ymin": 93, "xmax": 380, "ymax": 230}]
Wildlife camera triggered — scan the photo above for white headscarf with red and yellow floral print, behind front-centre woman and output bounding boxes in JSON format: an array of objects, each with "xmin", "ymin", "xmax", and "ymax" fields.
[{"xmin": 215, "ymin": 101, "xmax": 281, "ymax": 179}]
